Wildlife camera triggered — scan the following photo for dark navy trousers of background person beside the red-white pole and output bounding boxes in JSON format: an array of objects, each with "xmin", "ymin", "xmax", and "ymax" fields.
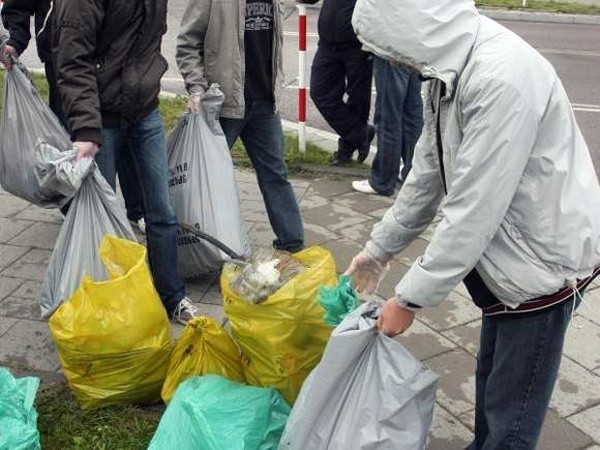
[{"xmin": 310, "ymin": 43, "xmax": 373, "ymax": 157}]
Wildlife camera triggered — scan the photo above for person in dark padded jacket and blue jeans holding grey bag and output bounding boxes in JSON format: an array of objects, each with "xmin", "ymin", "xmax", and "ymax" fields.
[{"xmin": 52, "ymin": 0, "xmax": 196, "ymax": 323}]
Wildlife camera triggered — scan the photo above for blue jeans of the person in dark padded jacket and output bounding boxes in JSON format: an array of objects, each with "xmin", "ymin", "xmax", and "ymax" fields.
[{"xmin": 96, "ymin": 109, "xmax": 185, "ymax": 315}]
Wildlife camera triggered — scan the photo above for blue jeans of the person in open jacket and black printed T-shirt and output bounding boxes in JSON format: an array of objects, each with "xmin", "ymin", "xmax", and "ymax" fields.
[{"xmin": 220, "ymin": 100, "xmax": 304, "ymax": 252}]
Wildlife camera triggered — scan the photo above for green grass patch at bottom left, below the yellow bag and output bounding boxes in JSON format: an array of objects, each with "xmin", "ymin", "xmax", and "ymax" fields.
[{"xmin": 36, "ymin": 385, "xmax": 163, "ymax": 450}]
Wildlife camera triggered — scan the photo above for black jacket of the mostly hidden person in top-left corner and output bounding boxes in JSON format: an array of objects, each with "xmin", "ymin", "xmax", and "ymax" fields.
[{"xmin": 2, "ymin": 0, "xmax": 52, "ymax": 63}]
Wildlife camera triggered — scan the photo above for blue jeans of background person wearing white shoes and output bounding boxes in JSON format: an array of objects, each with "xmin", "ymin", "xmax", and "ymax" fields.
[{"xmin": 369, "ymin": 56, "xmax": 423, "ymax": 195}]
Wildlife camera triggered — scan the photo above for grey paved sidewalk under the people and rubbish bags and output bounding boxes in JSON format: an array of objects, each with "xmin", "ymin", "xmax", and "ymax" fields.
[{"xmin": 0, "ymin": 156, "xmax": 600, "ymax": 450}]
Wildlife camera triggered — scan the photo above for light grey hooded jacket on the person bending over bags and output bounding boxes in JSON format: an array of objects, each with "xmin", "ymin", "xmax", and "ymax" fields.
[{"xmin": 353, "ymin": 0, "xmax": 600, "ymax": 307}]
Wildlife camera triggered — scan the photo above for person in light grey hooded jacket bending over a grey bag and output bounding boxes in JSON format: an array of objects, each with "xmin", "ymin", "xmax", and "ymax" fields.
[{"xmin": 346, "ymin": 0, "xmax": 600, "ymax": 450}]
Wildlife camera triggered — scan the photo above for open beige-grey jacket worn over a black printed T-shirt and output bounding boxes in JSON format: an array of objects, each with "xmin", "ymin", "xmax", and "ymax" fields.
[{"xmin": 176, "ymin": 0, "xmax": 283, "ymax": 119}]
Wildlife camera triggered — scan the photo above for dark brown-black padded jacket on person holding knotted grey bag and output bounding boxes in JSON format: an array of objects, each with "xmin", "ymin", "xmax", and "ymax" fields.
[{"xmin": 52, "ymin": 0, "xmax": 167, "ymax": 143}]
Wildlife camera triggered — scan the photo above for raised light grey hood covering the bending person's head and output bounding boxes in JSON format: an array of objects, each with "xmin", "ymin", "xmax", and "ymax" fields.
[{"xmin": 352, "ymin": 0, "xmax": 480, "ymax": 94}]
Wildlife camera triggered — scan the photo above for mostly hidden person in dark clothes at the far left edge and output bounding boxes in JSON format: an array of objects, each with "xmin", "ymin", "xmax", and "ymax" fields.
[{"xmin": 0, "ymin": 0, "xmax": 146, "ymax": 232}]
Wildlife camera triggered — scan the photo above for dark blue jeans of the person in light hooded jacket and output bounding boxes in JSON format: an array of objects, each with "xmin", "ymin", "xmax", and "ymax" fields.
[{"xmin": 468, "ymin": 299, "xmax": 575, "ymax": 450}]
